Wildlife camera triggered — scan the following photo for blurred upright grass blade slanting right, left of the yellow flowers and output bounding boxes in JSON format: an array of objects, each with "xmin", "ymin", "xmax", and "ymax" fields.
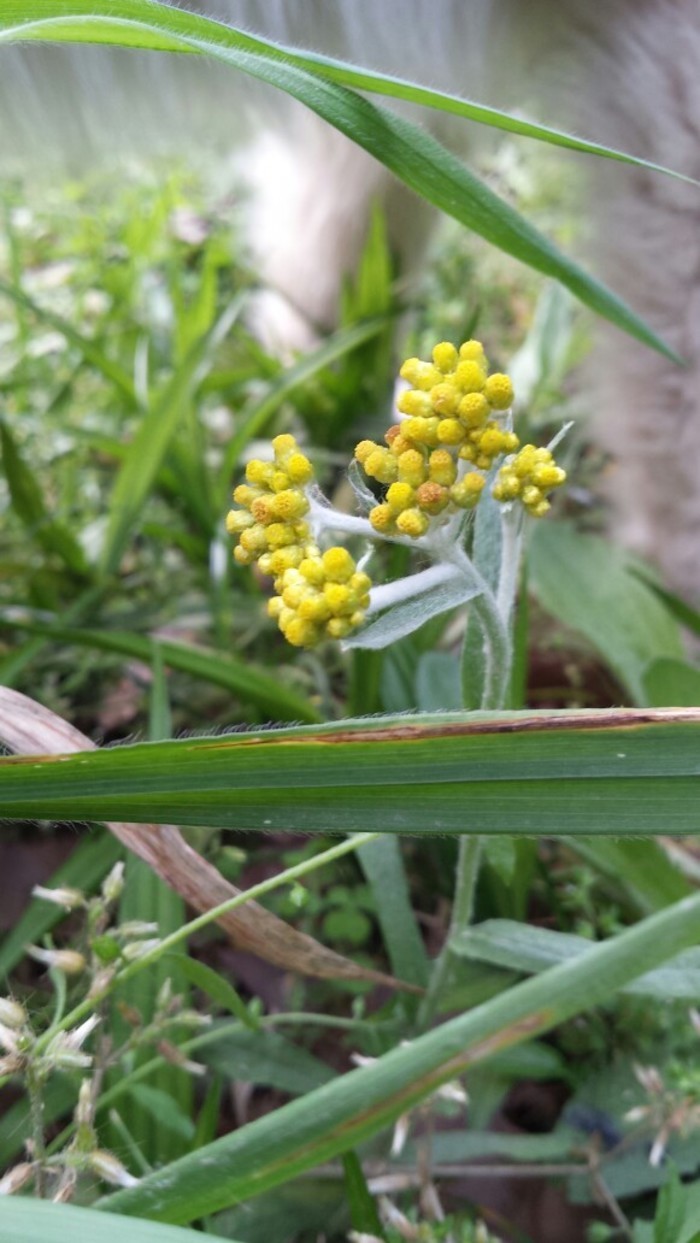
[{"xmin": 102, "ymin": 293, "xmax": 247, "ymax": 574}]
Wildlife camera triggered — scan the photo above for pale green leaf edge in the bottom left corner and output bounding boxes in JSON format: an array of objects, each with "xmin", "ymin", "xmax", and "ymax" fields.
[{"xmin": 0, "ymin": 1196, "xmax": 244, "ymax": 1243}]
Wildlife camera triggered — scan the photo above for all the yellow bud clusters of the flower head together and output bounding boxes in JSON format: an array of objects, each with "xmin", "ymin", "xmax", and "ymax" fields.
[{"xmin": 226, "ymin": 341, "xmax": 566, "ymax": 648}]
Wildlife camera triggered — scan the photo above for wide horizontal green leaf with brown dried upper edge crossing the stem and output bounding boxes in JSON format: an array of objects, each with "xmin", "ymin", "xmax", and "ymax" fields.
[{"xmin": 0, "ymin": 706, "xmax": 700, "ymax": 837}]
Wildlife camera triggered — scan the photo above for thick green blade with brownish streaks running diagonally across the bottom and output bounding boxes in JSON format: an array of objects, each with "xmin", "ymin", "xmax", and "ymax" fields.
[{"xmin": 101, "ymin": 895, "xmax": 700, "ymax": 1223}]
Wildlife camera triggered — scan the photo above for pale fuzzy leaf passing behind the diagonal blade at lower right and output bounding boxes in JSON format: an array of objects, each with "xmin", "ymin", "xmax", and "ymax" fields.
[{"xmin": 451, "ymin": 920, "xmax": 700, "ymax": 1002}]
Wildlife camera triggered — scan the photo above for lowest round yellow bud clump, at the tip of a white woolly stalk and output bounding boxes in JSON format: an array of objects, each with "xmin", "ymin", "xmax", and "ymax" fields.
[{"xmin": 267, "ymin": 548, "xmax": 372, "ymax": 648}]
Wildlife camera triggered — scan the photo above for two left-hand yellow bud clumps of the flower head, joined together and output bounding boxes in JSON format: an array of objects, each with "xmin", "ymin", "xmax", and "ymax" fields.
[{"xmin": 226, "ymin": 435, "xmax": 372, "ymax": 648}]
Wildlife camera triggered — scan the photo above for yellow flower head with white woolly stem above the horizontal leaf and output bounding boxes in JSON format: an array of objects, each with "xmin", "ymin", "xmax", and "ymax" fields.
[{"xmin": 226, "ymin": 341, "xmax": 566, "ymax": 709}]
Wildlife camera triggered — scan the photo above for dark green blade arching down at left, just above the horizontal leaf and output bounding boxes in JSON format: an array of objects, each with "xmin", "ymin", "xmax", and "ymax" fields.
[{"xmin": 0, "ymin": 618, "xmax": 318, "ymax": 721}]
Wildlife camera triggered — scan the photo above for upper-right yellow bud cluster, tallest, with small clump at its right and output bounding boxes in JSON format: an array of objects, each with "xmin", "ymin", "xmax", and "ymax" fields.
[{"xmin": 354, "ymin": 341, "xmax": 566, "ymax": 538}]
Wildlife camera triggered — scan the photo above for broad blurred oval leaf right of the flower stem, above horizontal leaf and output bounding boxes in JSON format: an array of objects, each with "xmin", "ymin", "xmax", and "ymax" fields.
[{"xmin": 527, "ymin": 522, "xmax": 684, "ymax": 704}]
